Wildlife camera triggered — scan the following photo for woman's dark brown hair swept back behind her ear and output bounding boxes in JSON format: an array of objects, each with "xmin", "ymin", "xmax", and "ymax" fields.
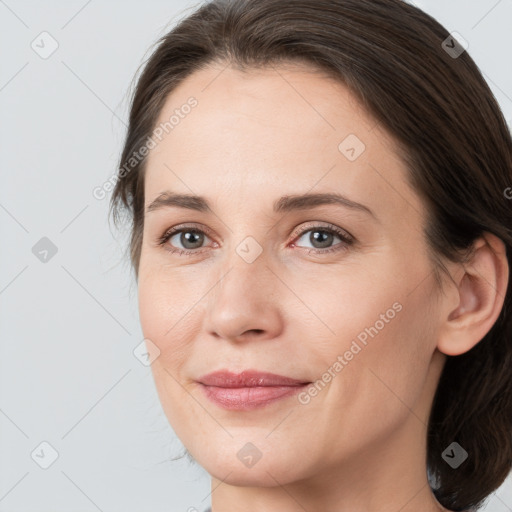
[{"xmin": 111, "ymin": 0, "xmax": 512, "ymax": 510}]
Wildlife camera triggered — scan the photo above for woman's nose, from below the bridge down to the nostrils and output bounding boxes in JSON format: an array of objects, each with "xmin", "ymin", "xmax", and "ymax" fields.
[{"xmin": 205, "ymin": 248, "xmax": 284, "ymax": 342}]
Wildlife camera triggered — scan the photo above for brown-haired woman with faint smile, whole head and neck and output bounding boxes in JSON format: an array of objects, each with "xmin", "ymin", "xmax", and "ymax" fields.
[{"xmin": 111, "ymin": 0, "xmax": 512, "ymax": 512}]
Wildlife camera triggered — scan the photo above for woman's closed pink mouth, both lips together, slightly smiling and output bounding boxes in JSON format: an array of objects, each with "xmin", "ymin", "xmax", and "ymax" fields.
[{"xmin": 198, "ymin": 370, "xmax": 311, "ymax": 410}]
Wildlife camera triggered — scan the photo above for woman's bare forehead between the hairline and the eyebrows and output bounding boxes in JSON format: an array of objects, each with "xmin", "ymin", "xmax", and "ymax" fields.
[{"xmin": 145, "ymin": 64, "xmax": 420, "ymax": 222}]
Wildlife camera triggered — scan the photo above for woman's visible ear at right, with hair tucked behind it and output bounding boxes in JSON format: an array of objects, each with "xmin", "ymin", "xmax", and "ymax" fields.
[{"xmin": 437, "ymin": 232, "xmax": 509, "ymax": 356}]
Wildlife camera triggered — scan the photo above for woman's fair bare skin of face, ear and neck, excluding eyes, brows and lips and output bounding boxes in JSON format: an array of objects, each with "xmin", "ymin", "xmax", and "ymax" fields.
[{"xmin": 138, "ymin": 64, "xmax": 508, "ymax": 512}]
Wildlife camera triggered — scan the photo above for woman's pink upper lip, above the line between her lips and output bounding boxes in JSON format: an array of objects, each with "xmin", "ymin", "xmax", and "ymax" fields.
[{"xmin": 198, "ymin": 370, "xmax": 310, "ymax": 388}]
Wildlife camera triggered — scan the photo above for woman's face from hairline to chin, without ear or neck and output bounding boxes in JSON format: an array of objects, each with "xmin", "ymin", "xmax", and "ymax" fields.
[{"xmin": 138, "ymin": 62, "xmax": 446, "ymax": 486}]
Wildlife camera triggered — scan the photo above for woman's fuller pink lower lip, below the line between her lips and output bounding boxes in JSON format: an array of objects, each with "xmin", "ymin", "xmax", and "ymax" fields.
[{"xmin": 201, "ymin": 384, "xmax": 309, "ymax": 411}]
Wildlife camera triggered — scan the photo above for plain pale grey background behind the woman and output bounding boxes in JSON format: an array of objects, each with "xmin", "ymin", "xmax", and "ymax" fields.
[{"xmin": 0, "ymin": 0, "xmax": 512, "ymax": 512}]
